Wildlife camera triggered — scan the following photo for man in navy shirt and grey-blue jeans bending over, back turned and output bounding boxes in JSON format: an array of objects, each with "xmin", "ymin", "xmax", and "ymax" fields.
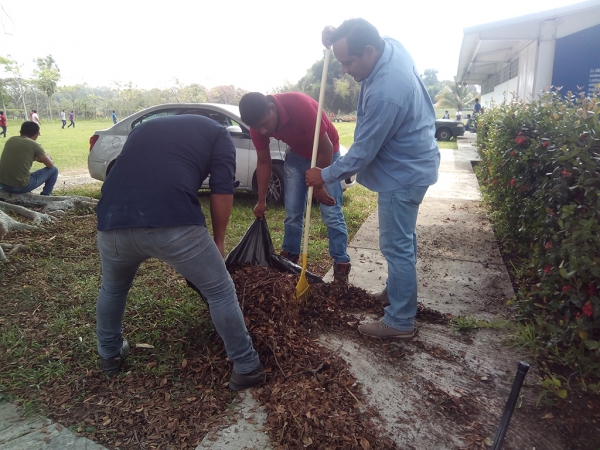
[{"xmin": 96, "ymin": 114, "xmax": 265, "ymax": 390}]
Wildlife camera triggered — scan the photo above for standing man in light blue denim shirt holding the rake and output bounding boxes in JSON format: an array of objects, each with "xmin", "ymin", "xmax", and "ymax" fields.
[{"xmin": 306, "ymin": 18, "xmax": 440, "ymax": 339}]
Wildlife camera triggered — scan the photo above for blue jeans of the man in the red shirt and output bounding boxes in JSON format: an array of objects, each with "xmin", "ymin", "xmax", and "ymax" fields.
[{"xmin": 282, "ymin": 152, "xmax": 350, "ymax": 263}]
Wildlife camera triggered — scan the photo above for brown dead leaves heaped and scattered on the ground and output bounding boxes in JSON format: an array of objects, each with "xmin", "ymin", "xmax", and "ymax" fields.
[{"xmin": 25, "ymin": 266, "xmax": 447, "ymax": 449}]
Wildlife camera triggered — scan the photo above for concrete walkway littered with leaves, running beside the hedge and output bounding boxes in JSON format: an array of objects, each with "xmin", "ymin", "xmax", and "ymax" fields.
[{"xmin": 0, "ymin": 133, "xmax": 558, "ymax": 450}]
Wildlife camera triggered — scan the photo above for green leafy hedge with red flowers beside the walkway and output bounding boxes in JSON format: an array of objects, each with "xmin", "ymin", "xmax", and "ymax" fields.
[{"xmin": 477, "ymin": 92, "xmax": 600, "ymax": 375}]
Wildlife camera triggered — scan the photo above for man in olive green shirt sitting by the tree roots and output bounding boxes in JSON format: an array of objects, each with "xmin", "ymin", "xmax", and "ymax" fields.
[{"xmin": 0, "ymin": 122, "xmax": 58, "ymax": 195}]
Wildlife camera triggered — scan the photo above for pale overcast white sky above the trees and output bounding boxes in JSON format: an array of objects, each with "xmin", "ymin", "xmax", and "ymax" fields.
[{"xmin": 0, "ymin": 0, "xmax": 600, "ymax": 93}]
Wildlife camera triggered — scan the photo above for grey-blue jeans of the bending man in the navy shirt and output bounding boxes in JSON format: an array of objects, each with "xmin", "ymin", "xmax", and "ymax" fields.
[{"xmin": 96, "ymin": 225, "xmax": 260, "ymax": 373}]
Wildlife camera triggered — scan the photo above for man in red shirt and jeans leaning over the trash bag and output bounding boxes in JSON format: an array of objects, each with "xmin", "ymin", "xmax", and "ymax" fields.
[{"xmin": 240, "ymin": 92, "xmax": 350, "ymax": 282}]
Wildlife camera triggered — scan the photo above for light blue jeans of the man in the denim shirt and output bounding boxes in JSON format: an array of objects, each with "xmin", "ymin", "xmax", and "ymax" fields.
[{"xmin": 377, "ymin": 186, "xmax": 428, "ymax": 331}]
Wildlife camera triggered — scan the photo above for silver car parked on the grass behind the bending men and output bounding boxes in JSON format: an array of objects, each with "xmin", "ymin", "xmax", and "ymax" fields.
[{"xmin": 88, "ymin": 103, "xmax": 356, "ymax": 203}]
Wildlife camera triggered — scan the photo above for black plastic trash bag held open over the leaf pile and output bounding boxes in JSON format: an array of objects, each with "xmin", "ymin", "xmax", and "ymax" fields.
[{"xmin": 225, "ymin": 218, "xmax": 275, "ymax": 266}]
